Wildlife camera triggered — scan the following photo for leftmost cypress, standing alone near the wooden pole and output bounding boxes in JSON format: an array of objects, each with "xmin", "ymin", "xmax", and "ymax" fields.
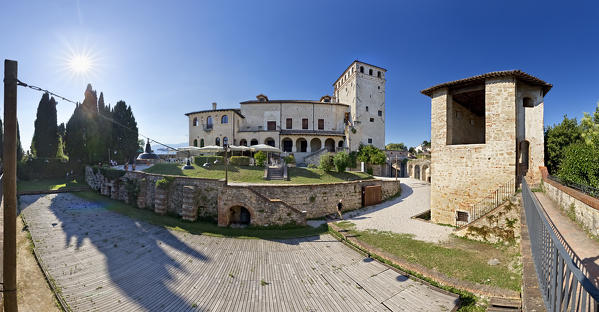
[{"xmin": 31, "ymin": 93, "xmax": 58, "ymax": 158}]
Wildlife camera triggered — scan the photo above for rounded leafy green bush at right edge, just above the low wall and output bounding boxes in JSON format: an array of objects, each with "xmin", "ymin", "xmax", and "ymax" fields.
[{"xmin": 558, "ymin": 143, "xmax": 599, "ymax": 188}]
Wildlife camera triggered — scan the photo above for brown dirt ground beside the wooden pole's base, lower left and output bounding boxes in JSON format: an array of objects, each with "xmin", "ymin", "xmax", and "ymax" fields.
[{"xmin": 0, "ymin": 217, "xmax": 61, "ymax": 312}]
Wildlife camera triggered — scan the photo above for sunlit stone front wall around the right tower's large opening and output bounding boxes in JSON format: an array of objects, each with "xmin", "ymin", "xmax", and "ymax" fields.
[{"xmin": 431, "ymin": 78, "xmax": 516, "ymax": 225}]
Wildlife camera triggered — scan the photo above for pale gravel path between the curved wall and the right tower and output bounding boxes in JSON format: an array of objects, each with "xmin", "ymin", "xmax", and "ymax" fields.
[{"xmin": 343, "ymin": 178, "xmax": 453, "ymax": 242}]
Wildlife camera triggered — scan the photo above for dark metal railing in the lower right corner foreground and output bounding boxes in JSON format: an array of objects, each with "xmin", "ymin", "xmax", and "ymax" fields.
[{"xmin": 522, "ymin": 179, "xmax": 599, "ymax": 312}]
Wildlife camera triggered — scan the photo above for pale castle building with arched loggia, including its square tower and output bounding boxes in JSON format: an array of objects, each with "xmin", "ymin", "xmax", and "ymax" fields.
[{"xmin": 185, "ymin": 61, "xmax": 386, "ymax": 163}]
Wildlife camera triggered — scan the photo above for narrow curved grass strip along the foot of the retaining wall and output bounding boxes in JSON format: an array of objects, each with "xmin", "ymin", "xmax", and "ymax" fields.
[{"xmin": 73, "ymin": 192, "xmax": 328, "ymax": 239}]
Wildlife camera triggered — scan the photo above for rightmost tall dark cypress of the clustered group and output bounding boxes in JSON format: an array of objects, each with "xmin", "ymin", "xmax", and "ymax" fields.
[{"xmin": 112, "ymin": 101, "xmax": 139, "ymax": 162}]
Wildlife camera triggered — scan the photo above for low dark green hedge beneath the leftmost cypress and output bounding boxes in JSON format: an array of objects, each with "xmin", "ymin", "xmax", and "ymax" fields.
[{"xmin": 17, "ymin": 158, "xmax": 68, "ymax": 180}]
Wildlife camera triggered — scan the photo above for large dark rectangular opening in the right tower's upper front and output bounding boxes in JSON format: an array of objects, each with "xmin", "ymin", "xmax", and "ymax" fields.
[{"xmin": 446, "ymin": 84, "xmax": 486, "ymax": 145}]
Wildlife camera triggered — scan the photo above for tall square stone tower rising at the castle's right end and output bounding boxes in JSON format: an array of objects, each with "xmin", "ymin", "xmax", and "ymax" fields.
[{"xmin": 333, "ymin": 61, "xmax": 387, "ymax": 151}]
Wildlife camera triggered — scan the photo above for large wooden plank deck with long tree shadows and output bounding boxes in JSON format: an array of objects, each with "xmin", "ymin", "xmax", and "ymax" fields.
[{"xmin": 20, "ymin": 194, "xmax": 457, "ymax": 311}]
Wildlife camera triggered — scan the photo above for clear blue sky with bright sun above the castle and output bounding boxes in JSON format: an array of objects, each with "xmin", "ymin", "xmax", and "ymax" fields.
[{"xmin": 0, "ymin": 0, "xmax": 599, "ymax": 148}]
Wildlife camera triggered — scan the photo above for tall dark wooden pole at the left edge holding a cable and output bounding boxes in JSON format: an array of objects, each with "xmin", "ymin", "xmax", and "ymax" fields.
[{"xmin": 2, "ymin": 60, "xmax": 18, "ymax": 312}]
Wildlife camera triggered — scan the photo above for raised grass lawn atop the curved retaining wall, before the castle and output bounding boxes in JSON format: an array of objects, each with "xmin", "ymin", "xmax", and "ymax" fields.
[{"xmin": 144, "ymin": 164, "xmax": 372, "ymax": 184}]
